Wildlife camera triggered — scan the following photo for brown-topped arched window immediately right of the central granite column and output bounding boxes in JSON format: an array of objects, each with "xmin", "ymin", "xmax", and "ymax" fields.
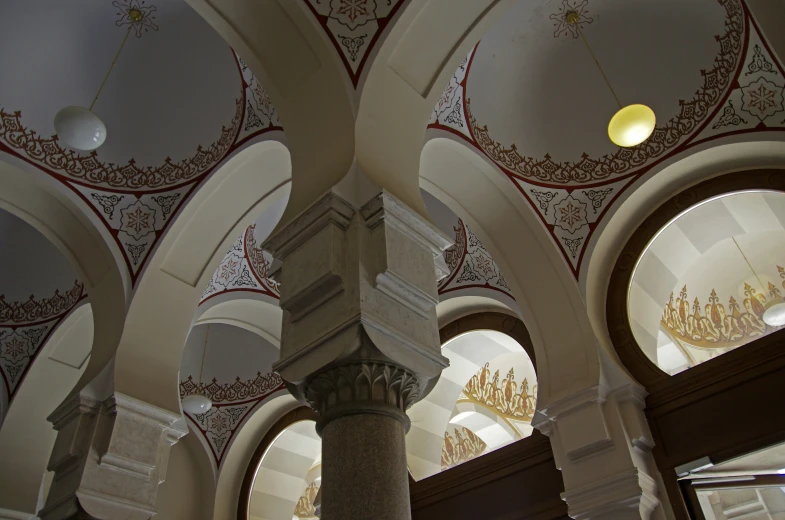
[{"xmin": 406, "ymin": 312, "xmax": 537, "ymax": 480}]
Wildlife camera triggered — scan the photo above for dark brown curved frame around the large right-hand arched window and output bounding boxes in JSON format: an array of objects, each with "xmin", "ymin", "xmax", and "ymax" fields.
[{"xmin": 605, "ymin": 169, "xmax": 785, "ymax": 389}]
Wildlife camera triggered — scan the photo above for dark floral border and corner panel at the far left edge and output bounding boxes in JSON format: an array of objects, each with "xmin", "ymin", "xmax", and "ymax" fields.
[{"xmin": 0, "ymin": 280, "xmax": 87, "ymax": 423}]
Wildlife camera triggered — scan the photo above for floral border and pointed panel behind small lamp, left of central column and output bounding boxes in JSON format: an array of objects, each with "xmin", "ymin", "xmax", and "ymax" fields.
[{"xmin": 180, "ymin": 372, "xmax": 285, "ymax": 469}]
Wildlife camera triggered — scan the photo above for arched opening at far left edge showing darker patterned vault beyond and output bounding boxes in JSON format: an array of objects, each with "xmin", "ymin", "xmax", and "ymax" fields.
[{"xmin": 0, "ymin": 210, "xmax": 93, "ymax": 515}]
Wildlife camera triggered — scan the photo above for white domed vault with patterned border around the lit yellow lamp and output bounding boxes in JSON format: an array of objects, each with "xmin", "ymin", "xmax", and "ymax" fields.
[{"xmin": 428, "ymin": 0, "xmax": 785, "ymax": 279}]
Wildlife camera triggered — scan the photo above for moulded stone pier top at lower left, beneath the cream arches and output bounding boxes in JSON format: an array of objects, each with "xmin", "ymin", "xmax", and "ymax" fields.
[{"xmin": 38, "ymin": 393, "xmax": 188, "ymax": 520}]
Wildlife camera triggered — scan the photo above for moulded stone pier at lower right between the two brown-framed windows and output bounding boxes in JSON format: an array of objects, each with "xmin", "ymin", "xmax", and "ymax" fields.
[{"xmin": 533, "ymin": 382, "xmax": 667, "ymax": 520}]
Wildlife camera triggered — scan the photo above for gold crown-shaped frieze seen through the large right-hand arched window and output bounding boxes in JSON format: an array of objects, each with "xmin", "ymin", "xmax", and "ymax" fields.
[{"xmin": 660, "ymin": 272, "xmax": 785, "ymax": 349}]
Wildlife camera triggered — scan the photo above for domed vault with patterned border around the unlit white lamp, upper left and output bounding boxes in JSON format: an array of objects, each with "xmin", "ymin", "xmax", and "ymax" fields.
[{"xmin": 0, "ymin": 0, "xmax": 282, "ymax": 283}]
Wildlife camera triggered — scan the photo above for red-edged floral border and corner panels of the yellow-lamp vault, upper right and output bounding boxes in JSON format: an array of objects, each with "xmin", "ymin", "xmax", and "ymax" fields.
[{"xmin": 428, "ymin": 0, "xmax": 785, "ymax": 279}]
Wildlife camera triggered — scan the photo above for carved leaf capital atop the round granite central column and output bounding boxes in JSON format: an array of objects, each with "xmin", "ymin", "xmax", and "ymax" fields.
[{"xmin": 305, "ymin": 361, "xmax": 422, "ymax": 433}]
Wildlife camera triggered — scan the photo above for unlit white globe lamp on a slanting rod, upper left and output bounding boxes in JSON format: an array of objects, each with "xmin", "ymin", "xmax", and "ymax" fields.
[{"xmin": 54, "ymin": 8, "xmax": 143, "ymax": 152}]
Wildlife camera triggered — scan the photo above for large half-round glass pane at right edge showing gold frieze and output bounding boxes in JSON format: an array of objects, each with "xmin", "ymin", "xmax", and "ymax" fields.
[{"xmin": 628, "ymin": 191, "xmax": 785, "ymax": 375}]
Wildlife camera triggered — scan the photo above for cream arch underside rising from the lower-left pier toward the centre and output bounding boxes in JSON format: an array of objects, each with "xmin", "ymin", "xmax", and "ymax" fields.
[{"xmin": 114, "ymin": 141, "xmax": 291, "ymax": 412}]
